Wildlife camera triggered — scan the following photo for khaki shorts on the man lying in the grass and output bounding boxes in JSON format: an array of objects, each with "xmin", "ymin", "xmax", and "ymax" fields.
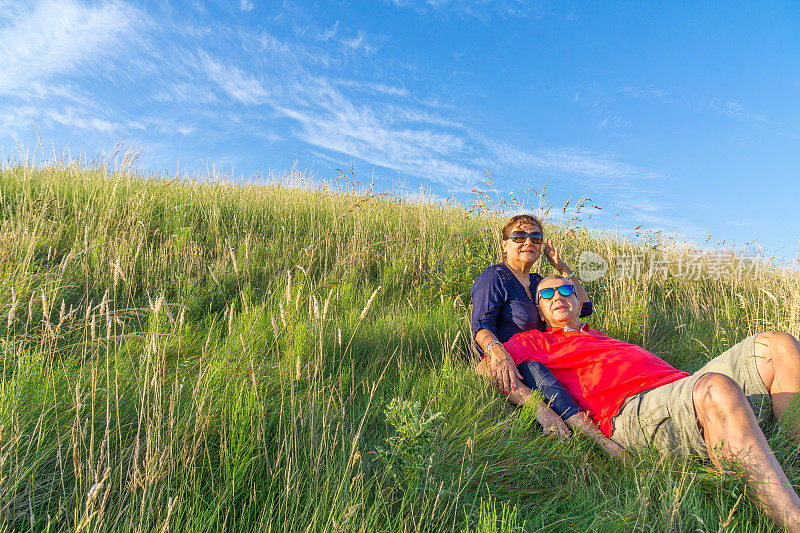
[{"xmin": 611, "ymin": 335, "xmax": 772, "ymax": 458}]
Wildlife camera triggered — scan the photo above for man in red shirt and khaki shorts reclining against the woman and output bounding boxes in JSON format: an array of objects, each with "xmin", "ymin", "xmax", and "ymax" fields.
[{"xmin": 504, "ymin": 276, "xmax": 800, "ymax": 532}]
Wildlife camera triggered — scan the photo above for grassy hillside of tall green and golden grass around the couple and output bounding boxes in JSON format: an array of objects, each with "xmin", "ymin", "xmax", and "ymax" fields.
[{"xmin": 0, "ymin": 165, "xmax": 800, "ymax": 532}]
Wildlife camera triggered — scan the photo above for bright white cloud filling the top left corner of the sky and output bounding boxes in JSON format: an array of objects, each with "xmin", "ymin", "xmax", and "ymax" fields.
[{"xmin": 0, "ymin": 0, "xmax": 141, "ymax": 94}]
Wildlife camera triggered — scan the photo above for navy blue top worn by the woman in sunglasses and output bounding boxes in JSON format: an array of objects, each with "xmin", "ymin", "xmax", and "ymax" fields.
[{"xmin": 470, "ymin": 263, "xmax": 592, "ymax": 355}]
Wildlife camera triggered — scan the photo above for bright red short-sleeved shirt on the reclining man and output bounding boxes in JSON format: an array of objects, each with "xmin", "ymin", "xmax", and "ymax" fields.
[{"xmin": 503, "ymin": 326, "xmax": 689, "ymax": 437}]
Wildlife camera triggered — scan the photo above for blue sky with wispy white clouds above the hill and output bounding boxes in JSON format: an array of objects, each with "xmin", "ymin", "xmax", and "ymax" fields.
[{"xmin": 0, "ymin": 0, "xmax": 800, "ymax": 260}]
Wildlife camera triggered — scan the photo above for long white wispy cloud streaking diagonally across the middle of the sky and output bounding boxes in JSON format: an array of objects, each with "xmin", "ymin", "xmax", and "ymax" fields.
[{"xmin": 189, "ymin": 24, "xmax": 655, "ymax": 191}]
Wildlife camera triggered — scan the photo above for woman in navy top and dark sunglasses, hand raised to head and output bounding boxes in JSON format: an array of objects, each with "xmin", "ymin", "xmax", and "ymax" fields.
[{"xmin": 471, "ymin": 215, "xmax": 625, "ymax": 457}]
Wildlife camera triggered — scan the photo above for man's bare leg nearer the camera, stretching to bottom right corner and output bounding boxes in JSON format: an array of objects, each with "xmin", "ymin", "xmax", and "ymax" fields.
[{"xmin": 692, "ymin": 373, "xmax": 800, "ymax": 532}]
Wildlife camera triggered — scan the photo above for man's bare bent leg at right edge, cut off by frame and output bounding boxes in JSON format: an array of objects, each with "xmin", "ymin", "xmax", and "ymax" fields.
[{"xmin": 755, "ymin": 331, "xmax": 800, "ymax": 424}]
